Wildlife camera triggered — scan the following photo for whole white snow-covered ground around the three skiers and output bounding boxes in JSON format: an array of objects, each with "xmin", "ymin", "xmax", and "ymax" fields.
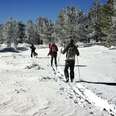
[{"xmin": 0, "ymin": 46, "xmax": 116, "ymax": 116}]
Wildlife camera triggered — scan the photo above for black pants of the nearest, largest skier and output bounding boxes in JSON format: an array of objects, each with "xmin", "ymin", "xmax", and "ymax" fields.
[{"xmin": 64, "ymin": 60, "xmax": 75, "ymax": 82}]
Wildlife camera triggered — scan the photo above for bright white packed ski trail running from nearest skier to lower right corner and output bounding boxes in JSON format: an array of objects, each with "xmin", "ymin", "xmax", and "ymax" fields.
[{"xmin": 55, "ymin": 67, "xmax": 116, "ymax": 116}]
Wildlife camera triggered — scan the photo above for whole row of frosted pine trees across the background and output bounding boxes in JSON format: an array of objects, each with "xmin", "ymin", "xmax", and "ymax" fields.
[{"xmin": 0, "ymin": 0, "xmax": 113, "ymax": 47}]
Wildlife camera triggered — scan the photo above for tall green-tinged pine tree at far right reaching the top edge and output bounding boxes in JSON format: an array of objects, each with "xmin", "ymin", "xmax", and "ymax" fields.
[{"xmin": 89, "ymin": 0, "xmax": 112, "ymax": 42}]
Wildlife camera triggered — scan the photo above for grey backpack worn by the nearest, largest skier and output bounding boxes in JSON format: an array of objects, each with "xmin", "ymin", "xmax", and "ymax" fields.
[{"xmin": 66, "ymin": 46, "xmax": 75, "ymax": 60}]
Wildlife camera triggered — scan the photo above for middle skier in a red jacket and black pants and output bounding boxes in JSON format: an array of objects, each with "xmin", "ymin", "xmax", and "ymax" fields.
[{"xmin": 48, "ymin": 43, "xmax": 58, "ymax": 67}]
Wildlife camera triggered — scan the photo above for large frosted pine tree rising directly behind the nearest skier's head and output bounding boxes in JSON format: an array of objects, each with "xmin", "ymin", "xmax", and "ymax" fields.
[{"xmin": 56, "ymin": 6, "xmax": 86, "ymax": 41}]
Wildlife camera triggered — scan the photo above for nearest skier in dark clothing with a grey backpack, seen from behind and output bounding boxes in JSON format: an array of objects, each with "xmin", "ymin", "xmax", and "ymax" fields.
[{"xmin": 61, "ymin": 39, "xmax": 79, "ymax": 82}]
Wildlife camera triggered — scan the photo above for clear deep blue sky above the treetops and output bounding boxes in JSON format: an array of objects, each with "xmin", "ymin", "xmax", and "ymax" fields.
[{"xmin": 0, "ymin": 0, "xmax": 107, "ymax": 23}]
